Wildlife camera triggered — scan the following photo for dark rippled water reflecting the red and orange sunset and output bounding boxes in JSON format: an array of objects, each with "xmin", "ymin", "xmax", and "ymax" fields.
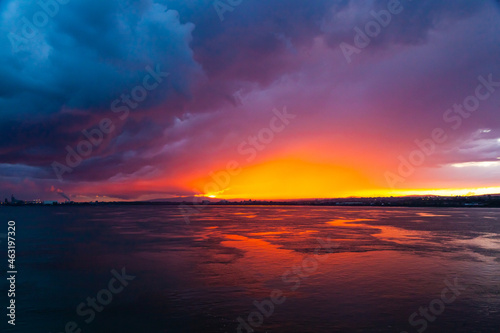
[{"xmin": 0, "ymin": 206, "xmax": 500, "ymax": 333}]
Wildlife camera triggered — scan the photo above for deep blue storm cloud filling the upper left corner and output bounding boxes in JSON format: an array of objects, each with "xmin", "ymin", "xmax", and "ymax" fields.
[{"xmin": 0, "ymin": 0, "xmax": 202, "ymax": 118}]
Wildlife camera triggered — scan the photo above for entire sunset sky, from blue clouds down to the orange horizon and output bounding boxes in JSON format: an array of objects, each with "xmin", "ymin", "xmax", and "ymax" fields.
[{"xmin": 0, "ymin": 0, "xmax": 500, "ymax": 201}]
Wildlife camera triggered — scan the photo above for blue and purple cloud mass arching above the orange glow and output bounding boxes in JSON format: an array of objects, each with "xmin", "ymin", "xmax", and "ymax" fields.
[{"xmin": 0, "ymin": 0, "xmax": 500, "ymax": 198}]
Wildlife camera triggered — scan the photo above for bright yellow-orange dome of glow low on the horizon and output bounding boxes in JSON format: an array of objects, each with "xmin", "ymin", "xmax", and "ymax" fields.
[{"xmin": 184, "ymin": 158, "xmax": 500, "ymax": 200}]
